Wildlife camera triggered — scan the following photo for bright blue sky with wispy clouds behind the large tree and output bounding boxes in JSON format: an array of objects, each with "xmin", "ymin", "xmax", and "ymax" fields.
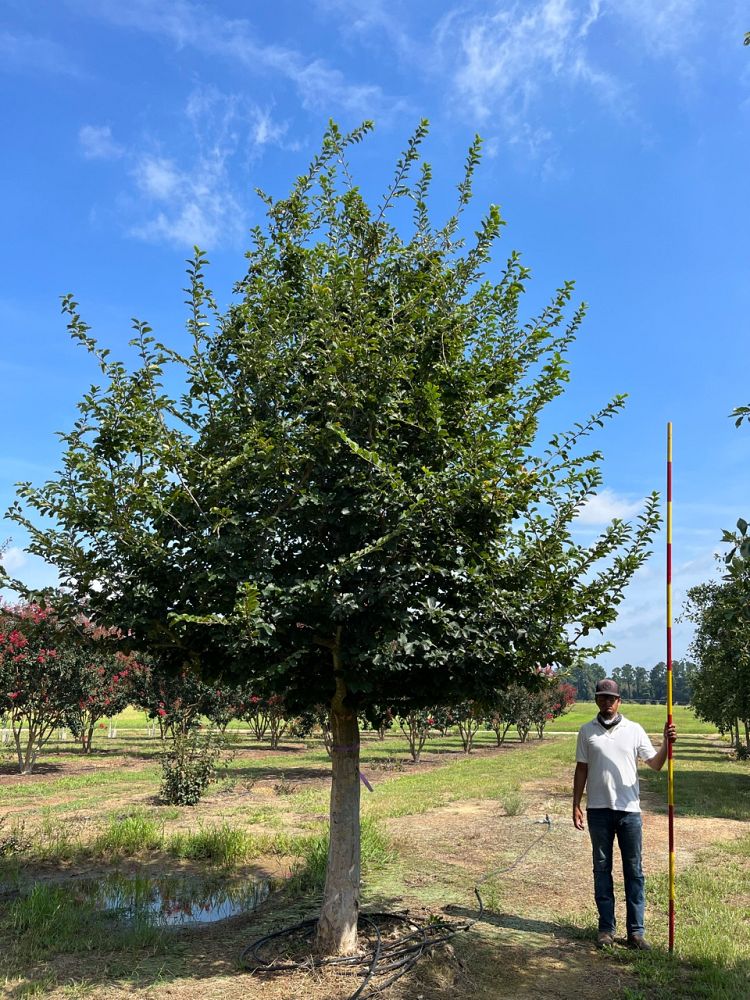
[{"xmin": 0, "ymin": 0, "xmax": 750, "ymax": 666}]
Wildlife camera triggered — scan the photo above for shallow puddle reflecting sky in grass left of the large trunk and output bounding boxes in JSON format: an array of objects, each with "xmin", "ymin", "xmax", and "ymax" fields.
[{"xmin": 64, "ymin": 874, "xmax": 271, "ymax": 927}]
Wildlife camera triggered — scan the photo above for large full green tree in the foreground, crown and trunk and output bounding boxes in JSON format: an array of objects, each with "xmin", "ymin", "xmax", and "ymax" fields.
[{"xmin": 12, "ymin": 123, "xmax": 658, "ymax": 953}]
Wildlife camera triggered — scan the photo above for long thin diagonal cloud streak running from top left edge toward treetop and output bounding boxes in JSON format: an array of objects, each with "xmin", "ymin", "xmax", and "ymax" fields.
[{"xmin": 77, "ymin": 0, "xmax": 403, "ymax": 117}]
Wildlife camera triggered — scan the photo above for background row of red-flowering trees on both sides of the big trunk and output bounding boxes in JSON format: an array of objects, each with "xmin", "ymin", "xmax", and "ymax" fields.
[{"xmin": 0, "ymin": 604, "xmax": 575, "ymax": 774}]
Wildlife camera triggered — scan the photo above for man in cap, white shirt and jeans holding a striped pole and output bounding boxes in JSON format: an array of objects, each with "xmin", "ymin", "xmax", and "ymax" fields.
[{"xmin": 573, "ymin": 678, "xmax": 677, "ymax": 951}]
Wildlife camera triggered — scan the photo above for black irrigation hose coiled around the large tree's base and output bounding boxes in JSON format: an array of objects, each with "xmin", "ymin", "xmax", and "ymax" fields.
[{"xmin": 239, "ymin": 816, "xmax": 552, "ymax": 1000}]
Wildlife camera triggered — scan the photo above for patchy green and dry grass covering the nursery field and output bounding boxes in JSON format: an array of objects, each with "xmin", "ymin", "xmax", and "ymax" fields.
[{"xmin": 0, "ymin": 706, "xmax": 750, "ymax": 1000}]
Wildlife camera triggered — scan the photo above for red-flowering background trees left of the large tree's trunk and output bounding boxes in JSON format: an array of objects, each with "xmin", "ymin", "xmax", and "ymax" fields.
[{"xmin": 0, "ymin": 603, "xmax": 311, "ymax": 774}]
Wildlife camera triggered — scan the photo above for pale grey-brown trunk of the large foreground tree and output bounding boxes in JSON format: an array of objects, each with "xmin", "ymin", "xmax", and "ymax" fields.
[{"xmin": 316, "ymin": 649, "xmax": 360, "ymax": 955}]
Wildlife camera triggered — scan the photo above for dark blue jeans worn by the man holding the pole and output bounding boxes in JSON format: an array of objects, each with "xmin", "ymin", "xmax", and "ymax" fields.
[{"xmin": 586, "ymin": 809, "xmax": 646, "ymax": 937}]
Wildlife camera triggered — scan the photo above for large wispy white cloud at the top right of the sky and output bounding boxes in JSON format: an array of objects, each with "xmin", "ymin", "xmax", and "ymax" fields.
[{"xmin": 434, "ymin": 0, "xmax": 707, "ymax": 158}]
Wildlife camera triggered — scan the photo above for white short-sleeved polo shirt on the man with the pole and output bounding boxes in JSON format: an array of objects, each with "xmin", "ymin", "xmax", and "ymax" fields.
[{"xmin": 576, "ymin": 718, "xmax": 656, "ymax": 812}]
